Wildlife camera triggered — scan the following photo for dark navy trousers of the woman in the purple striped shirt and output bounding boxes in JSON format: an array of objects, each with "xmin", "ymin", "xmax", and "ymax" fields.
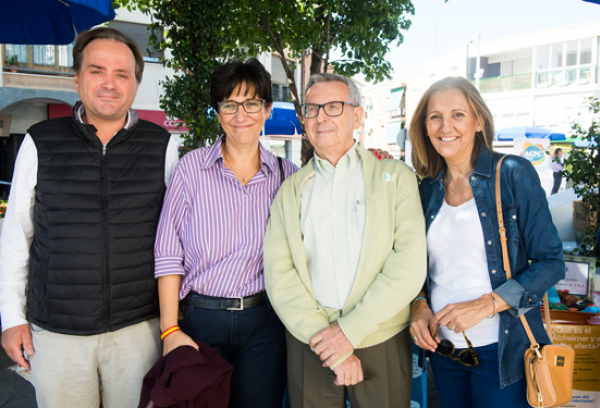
[{"xmin": 179, "ymin": 294, "xmax": 286, "ymax": 408}]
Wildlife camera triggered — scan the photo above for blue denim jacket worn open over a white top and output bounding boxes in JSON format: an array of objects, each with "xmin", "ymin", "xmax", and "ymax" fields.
[{"xmin": 420, "ymin": 149, "xmax": 565, "ymax": 388}]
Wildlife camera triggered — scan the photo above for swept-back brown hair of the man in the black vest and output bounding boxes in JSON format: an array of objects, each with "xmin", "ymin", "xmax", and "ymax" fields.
[{"xmin": 73, "ymin": 27, "xmax": 144, "ymax": 84}]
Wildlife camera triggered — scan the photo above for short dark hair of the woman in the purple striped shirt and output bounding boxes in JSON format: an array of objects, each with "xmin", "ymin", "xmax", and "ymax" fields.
[{"xmin": 210, "ymin": 58, "xmax": 273, "ymax": 112}]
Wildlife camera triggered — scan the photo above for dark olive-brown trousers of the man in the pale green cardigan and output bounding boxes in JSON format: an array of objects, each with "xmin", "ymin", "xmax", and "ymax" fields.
[{"xmin": 286, "ymin": 328, "xmax": 412, "ymax": 408}]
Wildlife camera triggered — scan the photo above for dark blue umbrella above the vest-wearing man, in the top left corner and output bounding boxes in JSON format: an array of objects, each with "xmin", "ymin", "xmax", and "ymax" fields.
[{"xmin": 0, "ymin": 0, "xmax": 115, "ymax": 45}]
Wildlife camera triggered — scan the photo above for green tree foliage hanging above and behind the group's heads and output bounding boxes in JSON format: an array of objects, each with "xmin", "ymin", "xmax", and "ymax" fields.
[{"xmin": 113, "ymin": 0, "xmax": 414, "ymax": 156}]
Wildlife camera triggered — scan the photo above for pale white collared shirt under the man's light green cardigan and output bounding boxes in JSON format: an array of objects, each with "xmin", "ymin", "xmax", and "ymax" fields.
[{"xmin": 300, "ymin": 144, "xmax": 366, "ymax": 310}]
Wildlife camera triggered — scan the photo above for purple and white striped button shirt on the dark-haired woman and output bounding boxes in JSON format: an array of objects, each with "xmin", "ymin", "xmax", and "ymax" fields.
[{"xmin": 154, "ymin": 135, "xmax": 298, "ymax": 299}]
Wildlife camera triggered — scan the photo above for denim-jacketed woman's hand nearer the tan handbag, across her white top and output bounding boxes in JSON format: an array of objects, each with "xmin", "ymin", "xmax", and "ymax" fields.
[{"xmin": 433, "ymin": 294, "xmax": 496, "ymax": 333}]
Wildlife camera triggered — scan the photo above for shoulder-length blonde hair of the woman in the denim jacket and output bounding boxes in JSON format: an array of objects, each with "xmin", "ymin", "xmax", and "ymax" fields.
[{"xmin": 408, "ymin": 77, "xmax": 494, "ymax": 177}]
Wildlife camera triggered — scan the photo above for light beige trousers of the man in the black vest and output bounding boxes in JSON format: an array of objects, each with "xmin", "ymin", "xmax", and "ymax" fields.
[{"xmin": 29, "ymin": 318, "xmax": 162, "ymax": 408}]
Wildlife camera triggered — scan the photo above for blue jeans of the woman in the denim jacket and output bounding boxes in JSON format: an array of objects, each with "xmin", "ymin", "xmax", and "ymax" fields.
[{"xmin": 429, "ymin": 343, "xmax": 529, "ymax": 408}]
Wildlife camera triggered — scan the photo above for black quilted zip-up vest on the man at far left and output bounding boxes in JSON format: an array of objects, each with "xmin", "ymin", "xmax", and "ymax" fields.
[{"xmin": 27, "ymin": 108, "xmax": 170, "ymax": 335}]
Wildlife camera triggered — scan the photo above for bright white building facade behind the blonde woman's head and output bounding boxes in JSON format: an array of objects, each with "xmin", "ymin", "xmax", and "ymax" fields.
[{"xmin": 363, "ymin": 22, "xmax": 600, "ymax": 156}]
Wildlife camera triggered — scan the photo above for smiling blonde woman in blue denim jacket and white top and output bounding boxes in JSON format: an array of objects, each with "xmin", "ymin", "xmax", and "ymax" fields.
[{"xmin": 410, "ymin": 77, "xmax": 565, "ymax": 408}]
